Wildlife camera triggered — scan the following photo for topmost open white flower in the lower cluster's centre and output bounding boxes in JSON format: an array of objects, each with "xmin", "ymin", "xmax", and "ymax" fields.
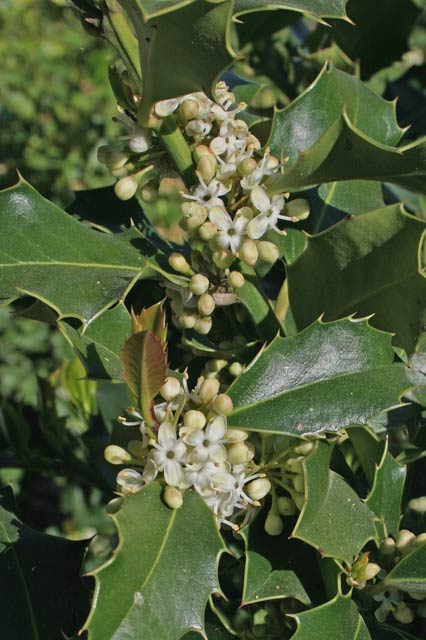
[{"xmin": 183, "ymin": 416, "xmax": 227, "ymax": 464}]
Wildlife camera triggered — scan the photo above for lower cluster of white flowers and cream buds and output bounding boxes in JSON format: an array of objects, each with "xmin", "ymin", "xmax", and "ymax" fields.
[{"xmin": 105, "ymin": 377, "xmax": 271, "ymax": 529}]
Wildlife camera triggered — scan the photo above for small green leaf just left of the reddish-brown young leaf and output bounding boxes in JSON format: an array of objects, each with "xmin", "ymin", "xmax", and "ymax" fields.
[{"xmin": 58, "ymin": 303, "xmax": 132, "ymax": 380}]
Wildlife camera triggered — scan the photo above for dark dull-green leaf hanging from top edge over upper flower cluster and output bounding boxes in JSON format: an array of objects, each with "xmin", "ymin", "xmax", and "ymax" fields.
[{"xmin": 124, "ymin": 0, "xmax": 234, "ymax": 118}]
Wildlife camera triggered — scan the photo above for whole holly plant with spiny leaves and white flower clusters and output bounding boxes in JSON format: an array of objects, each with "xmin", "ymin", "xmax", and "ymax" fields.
[{"xmin": 0, "ymin": 0, "xmax": 426, "ymax": 640}]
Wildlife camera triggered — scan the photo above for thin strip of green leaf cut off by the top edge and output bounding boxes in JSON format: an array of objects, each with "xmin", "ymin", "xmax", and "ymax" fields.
[{"xmin": 234, "ymin": 0, "xmax": 348, "ymax": 18}]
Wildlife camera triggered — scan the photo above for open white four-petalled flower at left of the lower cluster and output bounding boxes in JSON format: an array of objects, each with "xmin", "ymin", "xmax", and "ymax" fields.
[{"xmin": 152, "ymin": 422, "xmax": 186, "ymax": 487}]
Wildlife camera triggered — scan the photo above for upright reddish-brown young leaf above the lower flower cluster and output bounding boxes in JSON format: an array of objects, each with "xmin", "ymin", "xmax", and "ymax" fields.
[{"xmin": 121, "ymin": 330, "xmax": 167, "ymax": 425}]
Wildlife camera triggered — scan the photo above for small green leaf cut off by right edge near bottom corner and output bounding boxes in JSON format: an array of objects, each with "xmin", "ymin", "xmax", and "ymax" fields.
[{"xmin": 384, "ymin": 545, "xmax": 426, "ymax": 596}]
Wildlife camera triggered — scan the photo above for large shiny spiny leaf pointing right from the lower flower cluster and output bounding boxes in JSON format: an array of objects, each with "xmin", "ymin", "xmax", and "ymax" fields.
[{"xmin": 228, "ymin": 318, "xmax": 414, "ymax": 436}]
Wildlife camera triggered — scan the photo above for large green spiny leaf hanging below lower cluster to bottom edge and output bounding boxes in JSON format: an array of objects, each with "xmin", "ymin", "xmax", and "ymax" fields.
[{"xmin": 86, "ymin": 482, "xmax": 228, "ymax": 640}]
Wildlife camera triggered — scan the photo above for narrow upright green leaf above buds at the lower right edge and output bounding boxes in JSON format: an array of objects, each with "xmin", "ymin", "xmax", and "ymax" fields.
[{"xmin": 366, "ymin": 446, "xmax": 407, "ymax": 539}]
